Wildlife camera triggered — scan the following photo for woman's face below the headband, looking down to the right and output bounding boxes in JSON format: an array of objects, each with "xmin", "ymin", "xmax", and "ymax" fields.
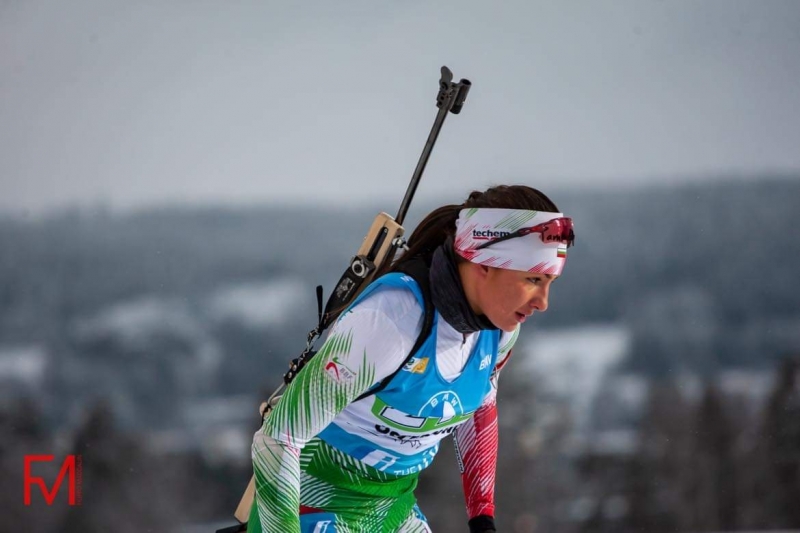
[{"xmin": 470, "ymin": 265, "xmax": 556, "ymax": 332}]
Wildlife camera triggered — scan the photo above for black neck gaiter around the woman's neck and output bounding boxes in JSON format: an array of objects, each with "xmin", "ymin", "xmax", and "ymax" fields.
[{"xmin": 429, "ymin": 237, "xmax": 497, "ymax": 335}]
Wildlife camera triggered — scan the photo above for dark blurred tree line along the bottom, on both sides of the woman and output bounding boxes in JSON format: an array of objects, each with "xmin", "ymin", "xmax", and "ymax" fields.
[{"xmin": 0, "ymin": 357, "xmax": 800, "ymax": 533}]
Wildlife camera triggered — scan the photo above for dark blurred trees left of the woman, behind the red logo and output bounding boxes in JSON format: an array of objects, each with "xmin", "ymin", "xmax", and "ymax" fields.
[{"xmin": 0, "ymin": 398, "xmax": 250, "ymax": 533}]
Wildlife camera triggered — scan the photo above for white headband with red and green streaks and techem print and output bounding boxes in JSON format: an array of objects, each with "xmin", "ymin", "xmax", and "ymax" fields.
[{"xmin": 453, "ymin": 207, "xmax": 567, "ymax": 276}]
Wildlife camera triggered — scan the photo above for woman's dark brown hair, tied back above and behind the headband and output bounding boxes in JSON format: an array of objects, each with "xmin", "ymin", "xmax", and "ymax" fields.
[{"xmin": 376, "ymin": 185, "xmax": 558, "ymax": 277}]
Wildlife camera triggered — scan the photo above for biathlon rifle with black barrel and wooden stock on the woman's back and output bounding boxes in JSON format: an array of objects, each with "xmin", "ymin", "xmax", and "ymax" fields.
[{"xmin": 217, "ymin": 66, "xmax": 472, "ymax": 533}]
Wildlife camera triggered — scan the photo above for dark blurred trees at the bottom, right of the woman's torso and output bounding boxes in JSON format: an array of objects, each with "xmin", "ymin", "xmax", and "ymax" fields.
[{"xmin": 419, "ymin": 357, "xmax": 800, "ymax": 533}]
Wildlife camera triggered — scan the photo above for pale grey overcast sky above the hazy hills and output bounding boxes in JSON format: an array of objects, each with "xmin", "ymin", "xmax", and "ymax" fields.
[{"xmin": 0, "ymin": 0, "xmax": 800, "ymax": 212}]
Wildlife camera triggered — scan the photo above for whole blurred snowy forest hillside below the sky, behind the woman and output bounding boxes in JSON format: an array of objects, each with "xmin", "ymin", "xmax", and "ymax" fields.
[{"xmin": 0, "ymin": 177, "xmax": 800, "ymax": 533}]
